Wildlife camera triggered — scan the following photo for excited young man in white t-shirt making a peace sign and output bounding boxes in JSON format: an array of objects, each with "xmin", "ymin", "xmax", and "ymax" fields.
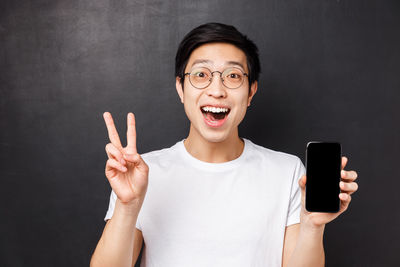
[{"xmin": 91, "ymin": 23, "xmax": 357, "ymax": 267}]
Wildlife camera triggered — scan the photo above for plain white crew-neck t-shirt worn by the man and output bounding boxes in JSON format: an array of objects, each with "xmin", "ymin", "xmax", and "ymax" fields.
[{"xmin": 105, "ymin": 138, "xmax": 305, "ymax": 267}]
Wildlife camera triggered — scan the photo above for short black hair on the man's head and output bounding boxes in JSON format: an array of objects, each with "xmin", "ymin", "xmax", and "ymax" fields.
[{"xmin": 175, "ymin": 22, "xmax": 261, "ymax": 90}]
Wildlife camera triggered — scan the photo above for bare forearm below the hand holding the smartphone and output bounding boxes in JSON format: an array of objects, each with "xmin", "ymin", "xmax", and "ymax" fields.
[{"xmin": 287, "ymin": 225, "xmax": 325, "ymax": 267}]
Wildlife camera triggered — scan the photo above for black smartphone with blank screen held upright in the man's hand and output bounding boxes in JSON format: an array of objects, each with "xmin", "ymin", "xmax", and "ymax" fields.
[{"xmin": 305, "ymin": 141, "xmax": 342, "ymax": 212}]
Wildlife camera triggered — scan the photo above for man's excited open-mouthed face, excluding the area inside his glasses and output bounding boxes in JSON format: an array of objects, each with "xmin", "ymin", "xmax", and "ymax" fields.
[{"xmin": 176, "ymin": 43, "xmax": 257, "ymax": 142}]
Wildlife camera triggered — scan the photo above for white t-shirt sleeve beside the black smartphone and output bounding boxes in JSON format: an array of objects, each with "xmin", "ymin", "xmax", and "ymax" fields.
[{"xmin": 286, "ymin": 158, "xmax": 306, "ymax": 226}]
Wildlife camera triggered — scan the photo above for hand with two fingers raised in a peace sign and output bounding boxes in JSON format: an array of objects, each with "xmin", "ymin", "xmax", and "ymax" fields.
[{"xmin": 103, "ymin": 112, "xmax": 149, "ymax": 204}]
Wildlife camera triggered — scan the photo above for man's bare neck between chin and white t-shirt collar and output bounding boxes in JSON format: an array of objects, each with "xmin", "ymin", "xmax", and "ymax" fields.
[{"xmin": 184, "ymin": 125, "xmax": 244, "ymax": 163}]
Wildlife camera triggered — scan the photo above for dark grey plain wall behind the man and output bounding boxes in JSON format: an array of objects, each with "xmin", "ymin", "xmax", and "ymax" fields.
[{"xmin": 0, "ymin": 0, "xmax": 400, "ymax": 267}]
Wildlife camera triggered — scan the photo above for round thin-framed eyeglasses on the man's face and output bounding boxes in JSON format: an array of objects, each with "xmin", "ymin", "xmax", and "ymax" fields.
[{"xmin": 185, "ymin": 67, "xmax": 248, "ymax": 89}]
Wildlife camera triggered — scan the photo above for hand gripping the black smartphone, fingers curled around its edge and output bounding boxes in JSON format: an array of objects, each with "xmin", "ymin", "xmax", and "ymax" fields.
[{"xmin": 299, "ymin": 157, "xmax": 358, "ymax": 228}]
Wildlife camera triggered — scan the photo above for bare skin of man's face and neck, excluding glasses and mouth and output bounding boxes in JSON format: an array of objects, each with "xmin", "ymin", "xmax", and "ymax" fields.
[{"xmin": 176, "ymin": 43, "xmax": 257, "ymax": 163}]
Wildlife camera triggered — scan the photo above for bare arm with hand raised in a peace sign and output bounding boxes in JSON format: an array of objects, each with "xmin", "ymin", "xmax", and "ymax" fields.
[{"xmin": 90, "ymin": 112, "xmax": 149, "ymax": 267}]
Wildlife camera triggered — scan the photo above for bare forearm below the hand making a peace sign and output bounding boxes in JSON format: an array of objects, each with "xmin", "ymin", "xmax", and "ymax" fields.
[{"xmin": 90, "ymin": 199, "xmax": 141, "ymax": 267}]
